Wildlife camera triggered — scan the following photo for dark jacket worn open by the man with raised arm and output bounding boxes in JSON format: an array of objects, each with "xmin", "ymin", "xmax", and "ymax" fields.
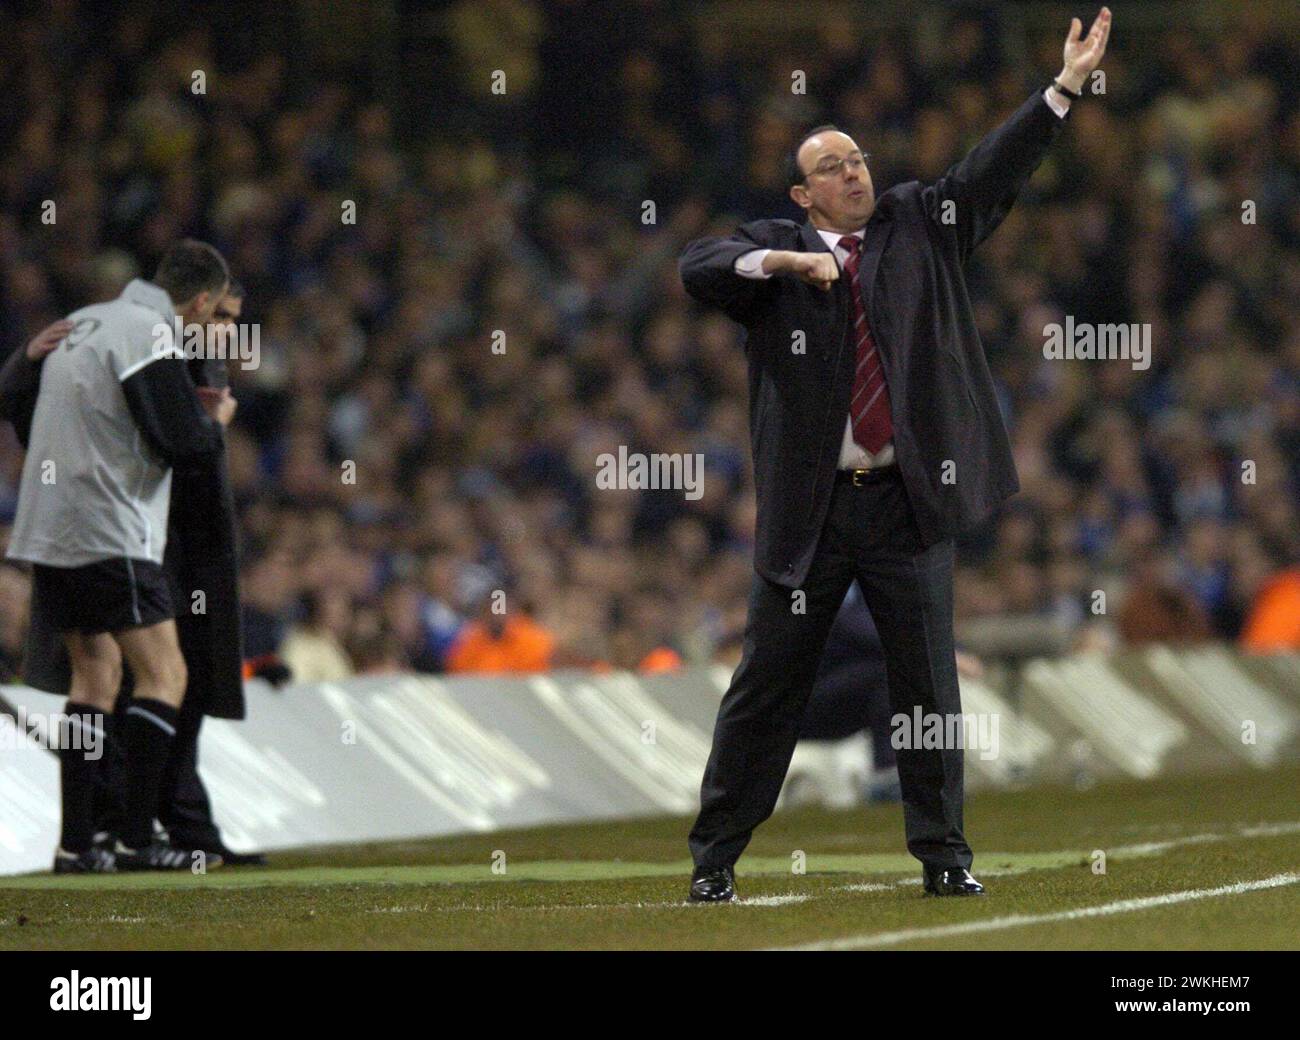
[{"xmin": 680, "ymin": 91, "xmax": 1063, "ymax": 589}]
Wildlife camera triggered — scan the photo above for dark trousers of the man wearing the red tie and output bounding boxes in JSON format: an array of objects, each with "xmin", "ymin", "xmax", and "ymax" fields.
[{"xmin": 690, "ymin": 467, "xmax": 972, "ymax": 870}]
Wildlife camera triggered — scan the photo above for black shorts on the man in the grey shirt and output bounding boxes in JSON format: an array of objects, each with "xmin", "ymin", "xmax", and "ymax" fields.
[{"xmin": 31, "ymin": 556, "xmax": 176, "ymax": 634}]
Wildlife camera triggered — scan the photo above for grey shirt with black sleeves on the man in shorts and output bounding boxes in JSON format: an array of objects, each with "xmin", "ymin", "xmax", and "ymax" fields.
[{"xmin": 8, "ymin": 280, "xmax": 220, "ymax": 567}]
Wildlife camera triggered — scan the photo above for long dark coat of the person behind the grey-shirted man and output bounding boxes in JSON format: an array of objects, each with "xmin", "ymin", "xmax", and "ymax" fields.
[{"xmin": 0, "ymin": 347, "xmax": 244, "ymax": 719}]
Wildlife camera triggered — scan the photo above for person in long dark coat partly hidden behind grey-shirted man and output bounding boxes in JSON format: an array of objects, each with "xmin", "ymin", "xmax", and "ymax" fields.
[{"xmin": 0, "ymin": 282, "xmax": 264, "ymax": 865}]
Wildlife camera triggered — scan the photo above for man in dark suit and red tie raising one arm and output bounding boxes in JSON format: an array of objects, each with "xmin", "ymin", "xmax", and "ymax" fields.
[{"xmin": 680, "ymin": 8, "xmax": 1110, "ymax": 902}]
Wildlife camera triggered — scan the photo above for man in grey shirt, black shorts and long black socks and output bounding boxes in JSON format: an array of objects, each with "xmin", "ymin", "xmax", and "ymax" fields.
[{"xmin": 8, "ymin": 241, "xmax": 234, "ymax": 872}]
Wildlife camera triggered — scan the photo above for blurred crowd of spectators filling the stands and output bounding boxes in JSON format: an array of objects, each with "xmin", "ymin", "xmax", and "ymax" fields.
[{"xmin": 0, "ymin": 0, "xmax": 1300, "ymax": 677}]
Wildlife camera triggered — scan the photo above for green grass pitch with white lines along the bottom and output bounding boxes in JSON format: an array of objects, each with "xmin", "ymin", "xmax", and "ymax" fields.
[{"xmin": 0, "ymin": 767, "xmax": 1300, "ymax": 949}]
